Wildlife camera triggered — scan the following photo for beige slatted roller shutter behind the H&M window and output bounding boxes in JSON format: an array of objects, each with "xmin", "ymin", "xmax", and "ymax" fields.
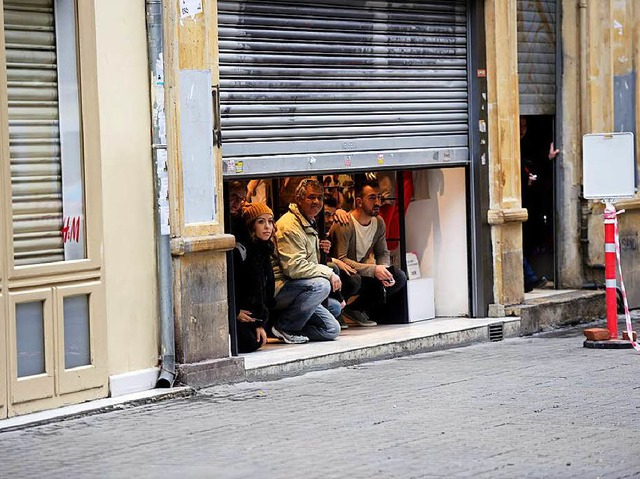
[{"xmin": 4, "ymin": 0, "xmax": 64, "ymax": 265}]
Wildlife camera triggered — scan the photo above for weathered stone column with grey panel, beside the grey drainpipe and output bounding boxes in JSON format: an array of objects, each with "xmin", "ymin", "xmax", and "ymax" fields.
[{"xmin": 163, "ymin": 0, "xmax": 244, "ymax": 387}]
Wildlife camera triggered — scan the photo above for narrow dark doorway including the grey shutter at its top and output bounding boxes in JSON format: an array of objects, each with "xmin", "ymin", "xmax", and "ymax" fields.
[{"xmin": 518, "ymin": 0, "xmax": 561, "ymax": 286}]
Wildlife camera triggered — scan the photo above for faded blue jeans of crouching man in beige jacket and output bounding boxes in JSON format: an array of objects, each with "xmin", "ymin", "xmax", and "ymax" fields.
[{"xmin": 274, "ymin": 278, "xmax": 340, "ymax": 341}]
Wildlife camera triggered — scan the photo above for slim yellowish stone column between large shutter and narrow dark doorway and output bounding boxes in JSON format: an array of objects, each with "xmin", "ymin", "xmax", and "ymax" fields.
[{"xmin": 485, "ymin": 0, "xmax": 527, "ymax": 305}]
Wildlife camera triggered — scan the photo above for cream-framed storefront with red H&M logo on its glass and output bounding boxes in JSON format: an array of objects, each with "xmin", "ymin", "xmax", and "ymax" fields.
[{"xmin": 0, "ymin": 0, "xmax": 108, "ymax": 419}]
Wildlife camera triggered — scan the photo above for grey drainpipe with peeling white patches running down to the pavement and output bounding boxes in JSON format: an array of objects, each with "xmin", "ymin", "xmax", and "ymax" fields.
[{"xmin": 146, "ymin": 0, "xmax": 176, "ymax": 388}]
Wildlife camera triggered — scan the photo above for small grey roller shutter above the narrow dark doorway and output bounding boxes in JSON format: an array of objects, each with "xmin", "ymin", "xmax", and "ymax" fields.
[{"xmin": 518, "ymin": 0, "xmax": 556, "ymax": 115}]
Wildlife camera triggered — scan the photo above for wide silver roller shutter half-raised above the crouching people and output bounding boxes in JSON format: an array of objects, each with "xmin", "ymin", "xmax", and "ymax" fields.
[{"xmin": 218, "ymin": 0, "xmax": 468, "ymax": 174}]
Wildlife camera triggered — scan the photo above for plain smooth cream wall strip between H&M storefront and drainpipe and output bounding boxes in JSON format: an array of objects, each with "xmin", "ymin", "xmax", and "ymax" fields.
[{"xmin": 96, "ymin": 0, "xmax": 158, "ymax": 374}]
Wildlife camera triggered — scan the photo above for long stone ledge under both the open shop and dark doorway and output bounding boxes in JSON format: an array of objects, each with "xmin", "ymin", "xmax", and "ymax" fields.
[{"xmin": 242, "ymin": 289, "xmax": 604, "ymax": 381}]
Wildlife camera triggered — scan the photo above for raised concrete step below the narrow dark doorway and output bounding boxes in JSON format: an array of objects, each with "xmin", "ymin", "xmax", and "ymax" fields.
[{"xmin": 505, "ymin": 289, "xmax": 606, "ymax": 335}]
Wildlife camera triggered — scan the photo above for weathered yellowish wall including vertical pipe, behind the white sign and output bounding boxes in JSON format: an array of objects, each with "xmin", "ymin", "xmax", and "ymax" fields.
[{"xmin": 558, "ymin": 0, "xmax": 640, "ymax": 300}]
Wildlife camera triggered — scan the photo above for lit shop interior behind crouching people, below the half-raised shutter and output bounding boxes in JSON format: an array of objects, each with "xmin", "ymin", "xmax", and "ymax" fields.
[{"xmin": 225, "ymin": 167, "xmax": 470, "ymax": 354}]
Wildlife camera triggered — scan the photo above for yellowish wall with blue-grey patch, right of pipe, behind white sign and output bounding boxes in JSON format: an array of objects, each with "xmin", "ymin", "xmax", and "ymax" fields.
[{"xmin": 582, "ymin": 0, "xmax": 640, "ymax": 307}]
